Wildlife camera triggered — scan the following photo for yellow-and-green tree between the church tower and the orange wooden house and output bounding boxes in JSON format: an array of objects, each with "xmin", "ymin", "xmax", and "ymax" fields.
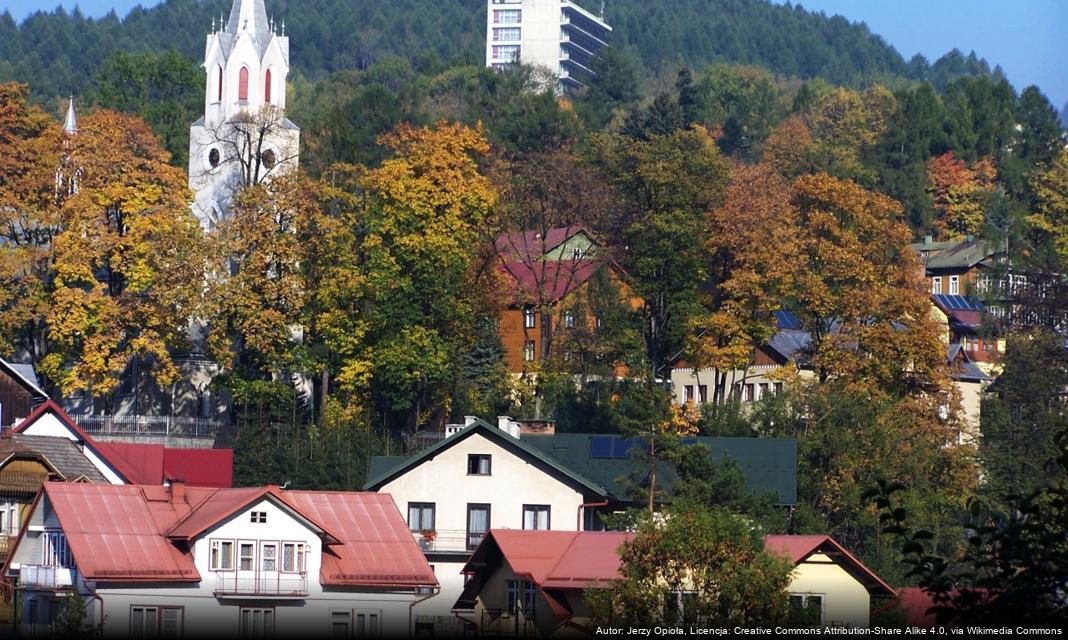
[{"xmin": 316, "ymin": 122, "xmax": 497, "ymax": 431}]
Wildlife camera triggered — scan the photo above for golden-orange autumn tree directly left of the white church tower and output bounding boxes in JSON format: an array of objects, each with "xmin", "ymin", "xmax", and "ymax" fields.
[{"xmin": 41, "ymin": 111, "xmax": 204, "ymax": 395}]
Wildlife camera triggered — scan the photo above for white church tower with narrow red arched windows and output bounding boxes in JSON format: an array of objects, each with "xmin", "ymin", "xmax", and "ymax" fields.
[{"xmin": 189, "ymin": 0, "xmax": 300, "ymax": 229}]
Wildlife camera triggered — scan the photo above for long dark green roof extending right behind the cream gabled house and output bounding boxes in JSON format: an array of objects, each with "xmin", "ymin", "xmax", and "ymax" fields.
[{"xmin": 522, "ymin": 434, "xmax": 798, "ymax": 504}]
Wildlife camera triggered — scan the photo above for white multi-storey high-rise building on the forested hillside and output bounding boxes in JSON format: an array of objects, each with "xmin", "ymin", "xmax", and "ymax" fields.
[{"xmin": 486, "ymin": 0, "xmax": 612, "ymax": 87}]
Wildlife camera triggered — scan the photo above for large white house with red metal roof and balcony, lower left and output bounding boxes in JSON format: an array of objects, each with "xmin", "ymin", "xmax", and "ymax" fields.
[{"xmin": 3, "ymin": 482, "xmax": 438, "ymax": 638}]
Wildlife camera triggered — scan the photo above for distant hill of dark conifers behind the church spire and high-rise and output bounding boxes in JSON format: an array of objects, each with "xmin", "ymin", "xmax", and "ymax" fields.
[{"xmin": 0, "ymin": 0, "xmax": 998, "ymax": 102}]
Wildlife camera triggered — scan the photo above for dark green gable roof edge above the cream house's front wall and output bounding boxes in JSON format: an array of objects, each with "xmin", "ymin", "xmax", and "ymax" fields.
[{"xmin": 364, "ymin": 419, "xmax": 609, "ymax": 498}]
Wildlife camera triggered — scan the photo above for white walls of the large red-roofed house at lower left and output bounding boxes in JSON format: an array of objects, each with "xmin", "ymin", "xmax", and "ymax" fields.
[{"xmin": 11, "ymin": 497, "xmax": 424, "ymax": 638}]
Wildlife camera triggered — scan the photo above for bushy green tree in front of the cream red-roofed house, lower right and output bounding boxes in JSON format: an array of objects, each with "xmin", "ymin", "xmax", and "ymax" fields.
[{"xmin": 584, "ymin": 505, "xmax": 791, "ymax": 627}]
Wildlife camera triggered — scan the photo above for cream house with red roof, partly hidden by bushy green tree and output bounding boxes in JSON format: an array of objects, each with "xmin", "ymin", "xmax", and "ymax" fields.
[{"xmin": 453, "ymin": 529, "xmax": 895, "ymax": 638}]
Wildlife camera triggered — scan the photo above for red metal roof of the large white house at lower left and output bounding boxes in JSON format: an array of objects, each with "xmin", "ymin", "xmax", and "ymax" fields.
[{"xmin": 24, "ymin": 483, "xmax": 438, "ymax": 589}]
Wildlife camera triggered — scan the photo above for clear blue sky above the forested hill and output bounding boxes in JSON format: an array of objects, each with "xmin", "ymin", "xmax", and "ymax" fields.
[{"xmin": 0, "ymin": 0, "xmax": 1068, "ymax": 110}]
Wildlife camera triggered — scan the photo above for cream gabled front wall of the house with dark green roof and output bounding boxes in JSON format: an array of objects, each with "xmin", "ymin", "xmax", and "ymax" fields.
[{"xmin": 377, "ymin": 425, "xmax": 602, "ymax": 635}]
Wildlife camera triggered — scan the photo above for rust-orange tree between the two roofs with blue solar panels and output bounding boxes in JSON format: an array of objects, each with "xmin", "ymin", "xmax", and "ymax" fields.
[{"xmin": 791, "ymin": 174, "xmax": 948, "ymax": 394}]
